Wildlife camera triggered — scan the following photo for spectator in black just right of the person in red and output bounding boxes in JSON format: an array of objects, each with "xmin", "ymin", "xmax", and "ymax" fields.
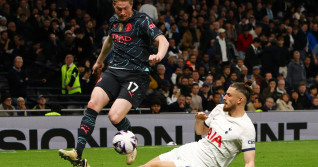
[{"xmin": 245, "ymin": 38, "xmax": 261, "ymax": 74}]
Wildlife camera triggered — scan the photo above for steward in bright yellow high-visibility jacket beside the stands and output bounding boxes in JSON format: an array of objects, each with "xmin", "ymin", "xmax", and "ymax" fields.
[{"xmin": 61, "ymin": 54, "xmax": 82, "ymax": 94}]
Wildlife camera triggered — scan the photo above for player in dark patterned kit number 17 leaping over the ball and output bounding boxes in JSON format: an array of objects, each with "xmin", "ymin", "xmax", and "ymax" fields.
[{"xmin": 59, "ymin": 0, "xmax": 169, "ymax": 167}]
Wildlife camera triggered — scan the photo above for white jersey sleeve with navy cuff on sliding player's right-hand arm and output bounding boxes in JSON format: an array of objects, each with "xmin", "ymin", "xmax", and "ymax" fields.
[{"xmin": 240, "ymin": 124, "xmax": 256, "ymax": 152}]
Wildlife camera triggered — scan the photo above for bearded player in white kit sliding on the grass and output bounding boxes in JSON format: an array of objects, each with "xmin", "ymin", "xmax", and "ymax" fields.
[{"xmin": 141, "ymin": 81, "xmax": 255, "ymax": 167}]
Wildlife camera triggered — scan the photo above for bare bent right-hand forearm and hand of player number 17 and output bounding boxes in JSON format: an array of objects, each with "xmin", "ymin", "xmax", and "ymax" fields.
[{"xmin": 149, "ymin": 35, "xmax": 169, "ymax": 65}]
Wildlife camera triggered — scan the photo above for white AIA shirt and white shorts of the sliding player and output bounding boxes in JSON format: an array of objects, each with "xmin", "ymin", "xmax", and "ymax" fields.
[{"xmin": 161, "ymin": 104, "xmax": 255, "ymax": 167}]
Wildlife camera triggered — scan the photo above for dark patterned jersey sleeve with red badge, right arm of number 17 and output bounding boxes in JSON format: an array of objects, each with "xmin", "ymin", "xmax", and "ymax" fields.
[{"xmin": 141, "ymin": 16, "xmax": 162, "ymax": 40}]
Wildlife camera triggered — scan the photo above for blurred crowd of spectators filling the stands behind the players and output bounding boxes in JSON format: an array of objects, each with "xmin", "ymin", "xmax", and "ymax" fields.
[{"xmin": 0, "ymin": 0, "xmax": 318, "ymax": 116}]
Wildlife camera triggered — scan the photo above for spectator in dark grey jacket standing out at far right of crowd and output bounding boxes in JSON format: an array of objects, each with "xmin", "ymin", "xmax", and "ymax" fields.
[{"xmin": 287, "ymin": 51, "xmax": 306, "ymax": 89}]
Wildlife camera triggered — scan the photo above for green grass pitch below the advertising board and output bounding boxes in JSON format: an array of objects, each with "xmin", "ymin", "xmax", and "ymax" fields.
[{"xmin": 0, "ymin": 140, "xmax": 318, "ymax": 167}]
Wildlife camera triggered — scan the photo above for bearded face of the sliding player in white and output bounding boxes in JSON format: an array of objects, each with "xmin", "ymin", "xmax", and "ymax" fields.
[{"xmin": 223, "ymin": 87, "xmax": 241, "ymax": 111}]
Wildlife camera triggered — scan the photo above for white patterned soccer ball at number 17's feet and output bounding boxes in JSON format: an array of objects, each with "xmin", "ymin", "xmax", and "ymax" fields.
[{"xmin": 113, "ymin": 130, "xmax": 137, "ymax": 154}]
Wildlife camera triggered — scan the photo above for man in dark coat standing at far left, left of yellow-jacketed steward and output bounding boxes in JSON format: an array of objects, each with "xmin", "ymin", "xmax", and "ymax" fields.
[{"xmin": 8, "ymin": 56, "xmax": 29, "ymax": 103}]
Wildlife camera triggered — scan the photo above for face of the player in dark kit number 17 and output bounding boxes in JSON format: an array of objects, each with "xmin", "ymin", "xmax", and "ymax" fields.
[{"xmin": 113, "ymin": 1, "xmax": 133, "ymax": 21}]
